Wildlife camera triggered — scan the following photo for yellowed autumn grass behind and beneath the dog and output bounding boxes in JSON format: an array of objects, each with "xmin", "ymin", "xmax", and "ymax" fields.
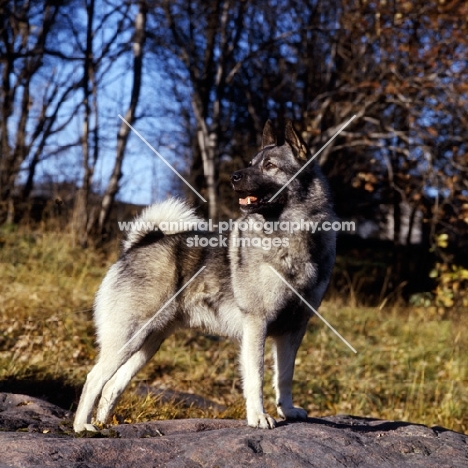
[{"xmin": 0, "ymin": 228, "xmax": 468, "ymax": 433}]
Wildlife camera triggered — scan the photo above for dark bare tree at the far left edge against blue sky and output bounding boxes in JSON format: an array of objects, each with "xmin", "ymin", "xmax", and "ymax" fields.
[{"xmin": 0, "ymin": 0, "xmax": 67, "ymax": 222}]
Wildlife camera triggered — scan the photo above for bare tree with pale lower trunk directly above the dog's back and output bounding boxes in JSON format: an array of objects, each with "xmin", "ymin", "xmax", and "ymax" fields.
[{"xmin": 151, "ymin": 0, "xmax": 247, "ymax": 220}]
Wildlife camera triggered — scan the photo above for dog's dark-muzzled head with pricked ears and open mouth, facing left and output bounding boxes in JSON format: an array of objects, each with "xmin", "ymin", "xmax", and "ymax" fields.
[{"xmin": 231, "ymin": 120, "xmax": 312, "ymax": 215}]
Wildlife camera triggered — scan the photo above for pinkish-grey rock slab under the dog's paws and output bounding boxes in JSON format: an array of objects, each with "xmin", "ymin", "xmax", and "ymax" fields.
[{"xmin": 0, "ymin": 394, "xmax": 468, "ymax": 468}]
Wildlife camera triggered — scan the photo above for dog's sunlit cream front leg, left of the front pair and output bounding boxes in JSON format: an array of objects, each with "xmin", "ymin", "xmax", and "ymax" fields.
[{"xmin": 241, "ymin": 314, "xmax": 276, "ymax": 429}]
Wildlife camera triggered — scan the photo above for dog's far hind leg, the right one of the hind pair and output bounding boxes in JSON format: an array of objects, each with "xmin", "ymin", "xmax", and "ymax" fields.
[{"xmin": 96, "ymin": 332, "xmax": 170, "ymax": 423}]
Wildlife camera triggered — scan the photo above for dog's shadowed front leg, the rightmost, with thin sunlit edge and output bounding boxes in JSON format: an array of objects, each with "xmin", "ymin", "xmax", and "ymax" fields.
[{"xmin": 273, "ymin": 327, "xmax": 307, "ymax": 419}]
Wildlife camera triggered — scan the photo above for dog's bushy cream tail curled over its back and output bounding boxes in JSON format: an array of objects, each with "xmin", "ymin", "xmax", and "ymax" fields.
[{"xmin": 122, "ymin": 198, "xmax": 203, "ymax": 252}]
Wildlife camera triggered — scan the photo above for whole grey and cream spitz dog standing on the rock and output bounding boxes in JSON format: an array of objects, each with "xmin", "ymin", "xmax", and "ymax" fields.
[{"xmin": 74, "ymin": 121, "xmax": 335, "ymax": 431}]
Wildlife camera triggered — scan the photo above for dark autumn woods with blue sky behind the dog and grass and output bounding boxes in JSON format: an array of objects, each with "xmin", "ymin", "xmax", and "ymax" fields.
[{"xmin": 0, "ymin": 0, "xmax": 468, "ymax": 311}]
